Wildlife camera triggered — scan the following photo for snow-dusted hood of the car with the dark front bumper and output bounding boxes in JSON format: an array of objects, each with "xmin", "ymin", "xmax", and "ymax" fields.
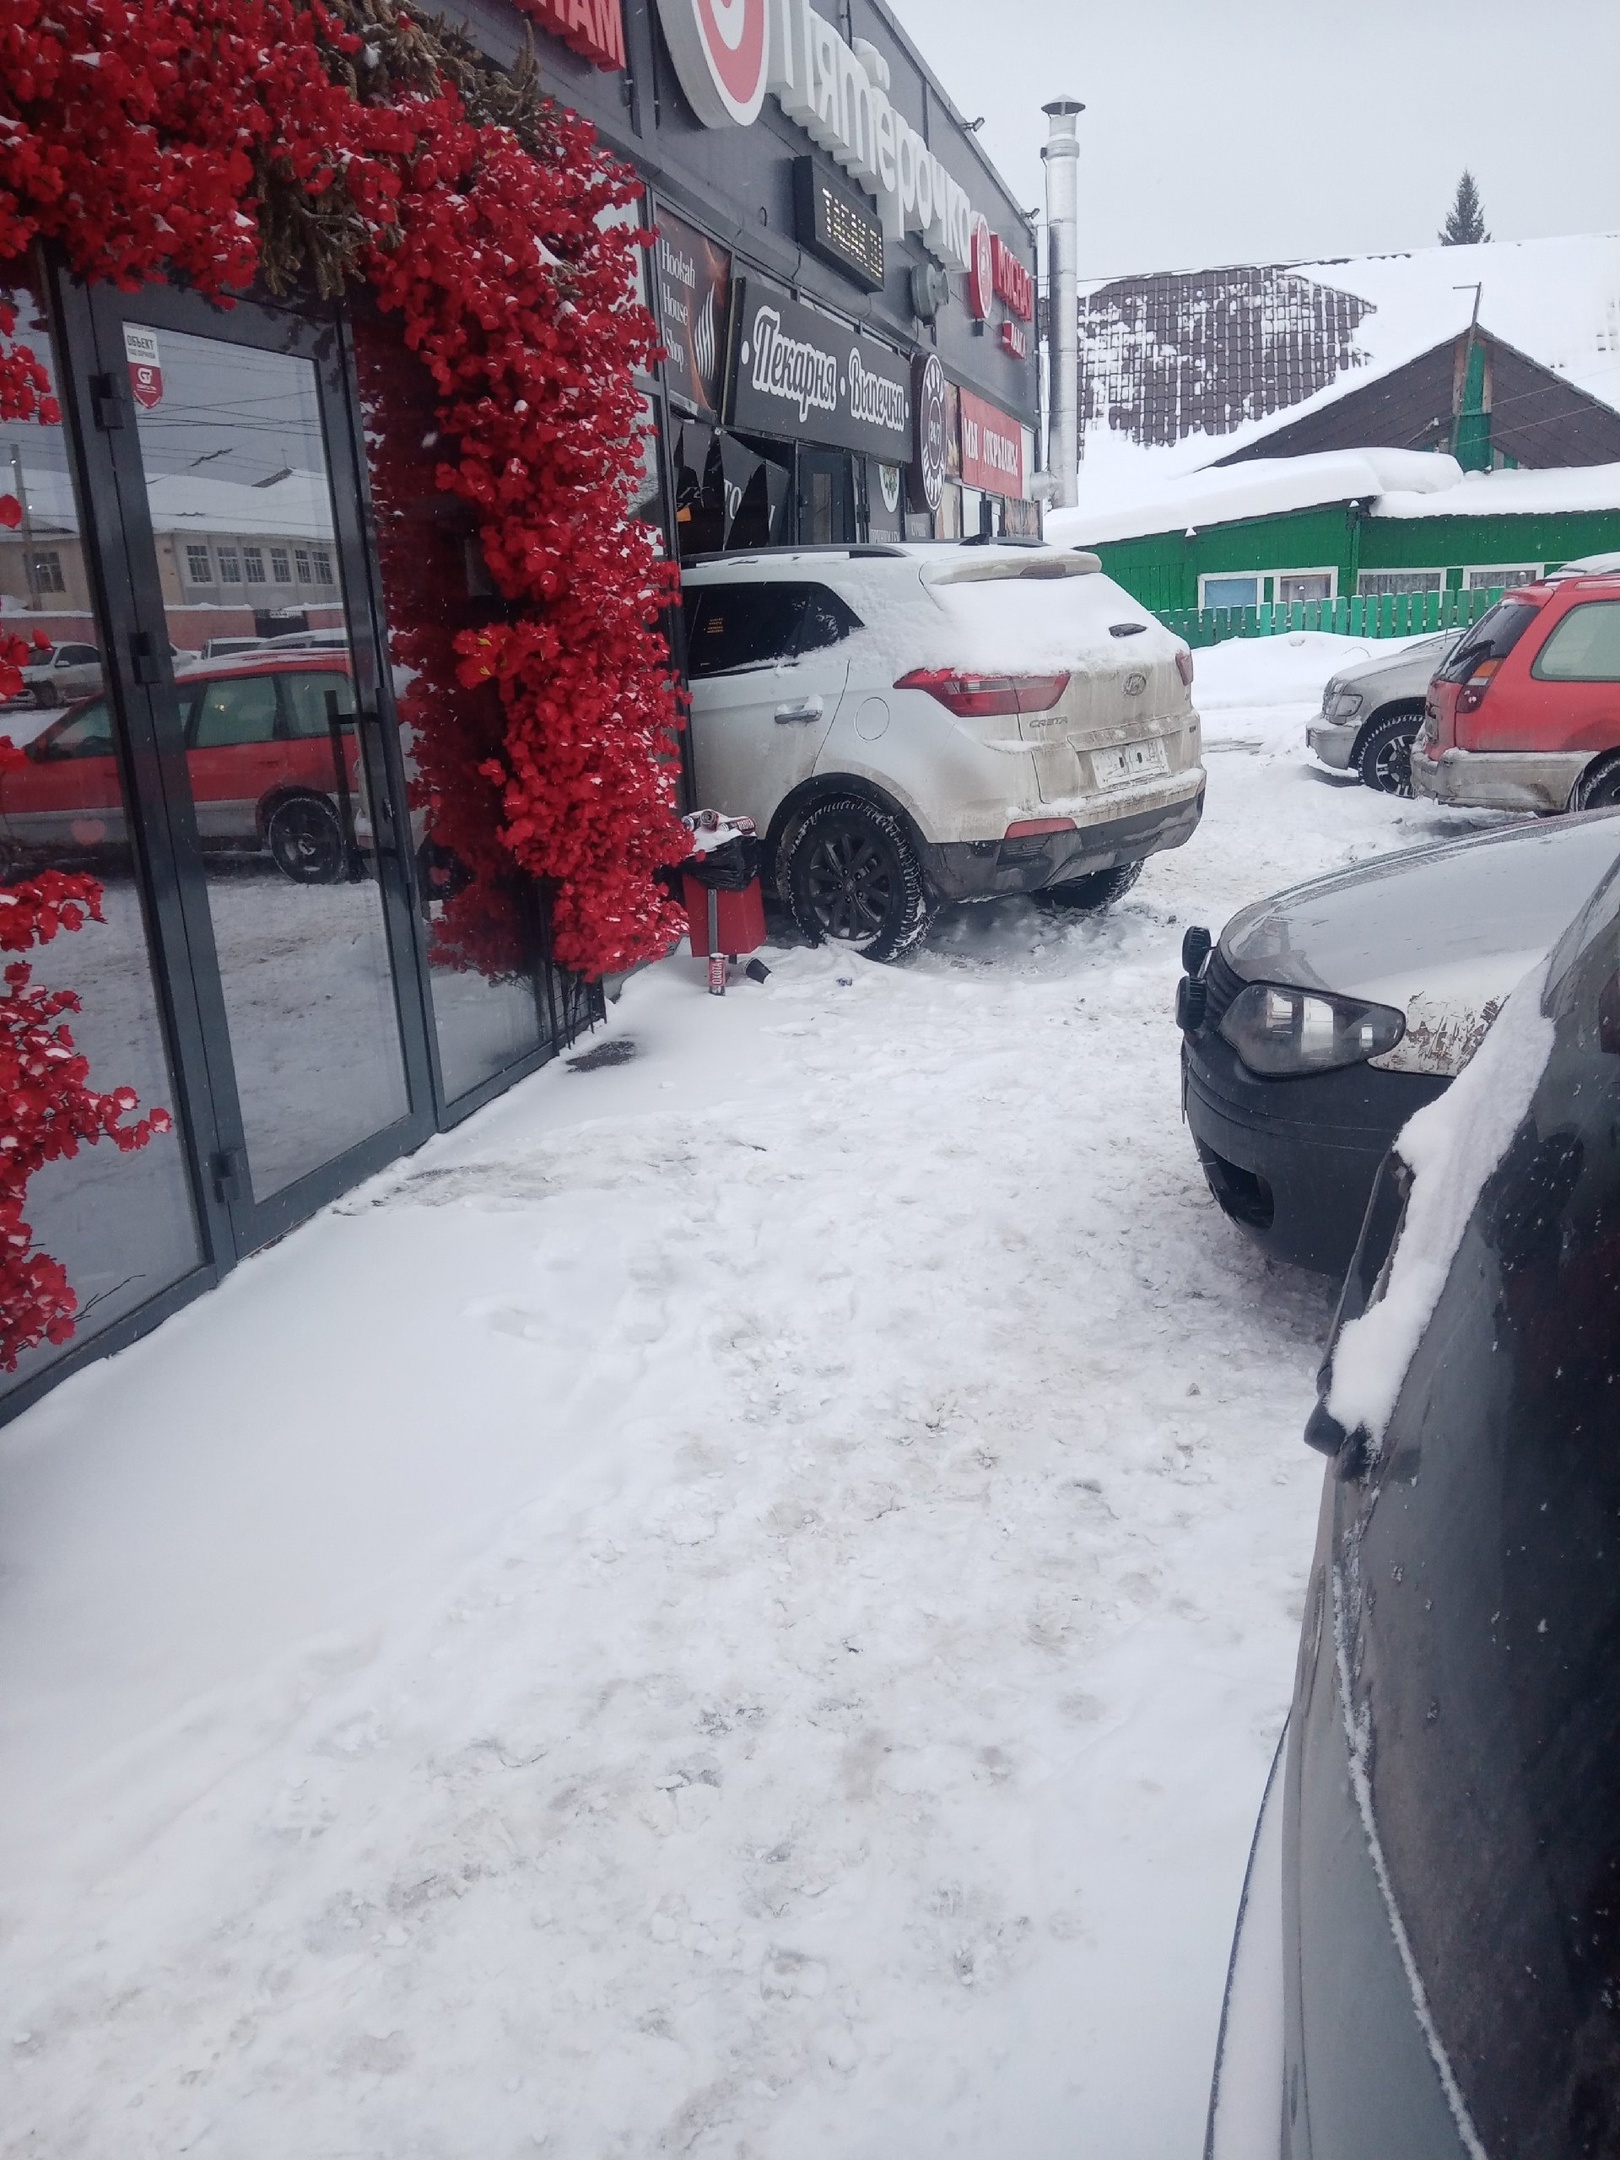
[{"xmin": 1220, "ymin": 810, "xmax": 1620, "ymax": 1074}]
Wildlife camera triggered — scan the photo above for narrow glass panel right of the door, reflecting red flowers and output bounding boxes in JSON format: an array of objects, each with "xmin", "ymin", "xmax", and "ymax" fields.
[{"xmin": 349, "ymin": 315, "xmax": 551, "ymax": 1102}]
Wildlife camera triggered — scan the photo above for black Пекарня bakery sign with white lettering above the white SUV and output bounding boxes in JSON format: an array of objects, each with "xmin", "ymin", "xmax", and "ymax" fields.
[{"xmin": 726, "ymin": 276, "xmax": 912, "ymax": 464}]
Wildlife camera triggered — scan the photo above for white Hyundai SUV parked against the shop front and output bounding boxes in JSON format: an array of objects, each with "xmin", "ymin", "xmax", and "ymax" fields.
[{"xmin": 683, "ymin": 542, "xmax": 1203, "ymax": 959}]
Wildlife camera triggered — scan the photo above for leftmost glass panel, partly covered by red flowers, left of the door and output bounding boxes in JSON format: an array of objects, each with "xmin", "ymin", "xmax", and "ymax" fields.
[{"xmin": 0, "ymin": 292, "xmax": 203, "ymax": 1395}]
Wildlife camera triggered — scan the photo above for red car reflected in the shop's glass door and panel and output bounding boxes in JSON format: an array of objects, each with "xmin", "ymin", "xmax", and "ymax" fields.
[{"xmin": 0, "ymin": 650, "xmax": 369, "ymax": 883}]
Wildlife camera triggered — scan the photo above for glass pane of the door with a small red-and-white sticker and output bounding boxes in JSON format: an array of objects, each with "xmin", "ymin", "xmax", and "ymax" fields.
[{"xmin": 126, "ymin": 328, "xmax": 408, "ymax": 1201}]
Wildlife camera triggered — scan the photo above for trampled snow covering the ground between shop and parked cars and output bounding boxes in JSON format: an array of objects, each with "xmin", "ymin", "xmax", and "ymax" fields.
[{"xmin": 0, "ymin": 637, "xmax": 1503, "ymax": 2160}]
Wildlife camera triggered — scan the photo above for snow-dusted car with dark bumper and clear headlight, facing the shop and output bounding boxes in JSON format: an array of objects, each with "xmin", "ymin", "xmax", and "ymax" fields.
[{"xmin": 1177, "ymin": 812, "xmax": 1620, "ymax": 1274}]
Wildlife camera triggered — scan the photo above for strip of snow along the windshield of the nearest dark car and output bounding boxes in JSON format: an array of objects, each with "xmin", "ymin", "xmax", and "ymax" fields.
[{"xmin": 1328, "ymin": 957, "xmax": 1553, "ymax": 1445}]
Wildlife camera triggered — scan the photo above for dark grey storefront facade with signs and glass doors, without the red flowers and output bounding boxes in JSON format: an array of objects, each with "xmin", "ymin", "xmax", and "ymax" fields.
[{"xmin": 0, "ymin": 0, "xmax": 1035, "ymax": 1415}]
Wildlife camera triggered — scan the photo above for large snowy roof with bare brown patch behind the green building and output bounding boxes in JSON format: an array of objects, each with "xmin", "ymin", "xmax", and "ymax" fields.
[{"xmin": 1080, "ymin": 233, "xmax": 1620, "ymax": 488}]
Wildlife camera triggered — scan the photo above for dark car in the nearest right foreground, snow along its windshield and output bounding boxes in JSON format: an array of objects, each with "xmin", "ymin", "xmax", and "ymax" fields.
[{"xmin": 1205, "ymin": 846, "xmax": 1620, "ymax": 2160}]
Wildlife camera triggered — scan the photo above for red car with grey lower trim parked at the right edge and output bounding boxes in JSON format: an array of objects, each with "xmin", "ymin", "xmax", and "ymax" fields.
[{"xmin": 1413, "ymin": 572, "xmax": 1620, "ymax": 812}]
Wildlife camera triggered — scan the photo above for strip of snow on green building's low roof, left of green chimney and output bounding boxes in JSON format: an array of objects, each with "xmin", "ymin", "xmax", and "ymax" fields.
[{"xmin": 1045, "ymin": 449, "xmax": 1462, "ymax": 546}]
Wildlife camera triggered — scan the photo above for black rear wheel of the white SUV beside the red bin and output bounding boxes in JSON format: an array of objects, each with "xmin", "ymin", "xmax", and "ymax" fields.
[{"xmin": 786, "ymin": 795, "xmax": 929, "ymax": 961}]
